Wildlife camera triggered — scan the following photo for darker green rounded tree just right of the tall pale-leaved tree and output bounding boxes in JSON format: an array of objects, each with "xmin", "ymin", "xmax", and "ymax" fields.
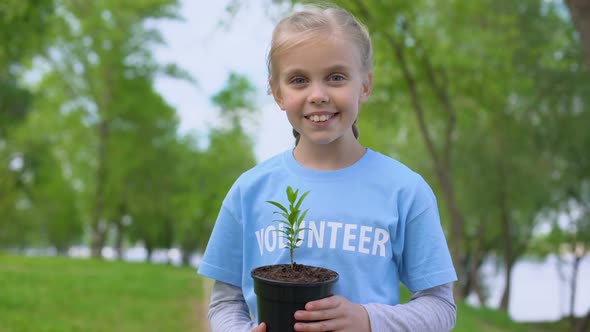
[{"xmin": 104, "ymin": 77, "xmax": 179, "ymax": 257}]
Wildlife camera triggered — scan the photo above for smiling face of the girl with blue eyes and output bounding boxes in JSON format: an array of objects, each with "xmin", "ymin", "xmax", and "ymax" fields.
[{"xmin": 271, "ymin": 36, "xmax": 372, "ymax": 148}]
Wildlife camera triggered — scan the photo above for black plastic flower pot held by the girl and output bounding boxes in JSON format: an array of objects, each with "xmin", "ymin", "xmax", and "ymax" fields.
[{"xmin": 251, "ymin": 266, "xmax": 338, "ymax": 332}]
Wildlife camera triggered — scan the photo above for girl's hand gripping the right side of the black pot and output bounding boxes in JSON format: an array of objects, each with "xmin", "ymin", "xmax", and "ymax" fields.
[{"xmin": 295, "ymin": 296, "xmax": 371, "ymax": 332}]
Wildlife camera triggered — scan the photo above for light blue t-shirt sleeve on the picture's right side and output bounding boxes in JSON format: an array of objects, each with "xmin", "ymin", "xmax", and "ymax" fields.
[{"xmin": 400, "ymin": 183, "xmax": 457, "ymax": 292}]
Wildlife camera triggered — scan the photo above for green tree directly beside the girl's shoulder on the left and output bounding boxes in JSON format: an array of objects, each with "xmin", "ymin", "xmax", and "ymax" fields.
[{"xmin": 175, "ymin": 72, "xmax": 256, "ymax": 263}]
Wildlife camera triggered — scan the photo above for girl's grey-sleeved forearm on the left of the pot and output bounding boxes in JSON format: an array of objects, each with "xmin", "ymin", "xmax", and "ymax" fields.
[{"xmin": 207, "ymin": 281, "xmax": 256, "ymax": 332}]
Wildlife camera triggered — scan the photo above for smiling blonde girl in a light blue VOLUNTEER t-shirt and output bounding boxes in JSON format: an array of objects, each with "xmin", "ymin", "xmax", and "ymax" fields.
[{"xmin": 199, "ymin": 3, "xmax": 457, "ymax": 332}]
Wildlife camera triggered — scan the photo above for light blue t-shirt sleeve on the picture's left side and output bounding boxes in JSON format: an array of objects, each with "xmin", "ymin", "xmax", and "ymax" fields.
[{"xmin": 198, "ymin": 190, "xmax": 243, "ymax": 287}]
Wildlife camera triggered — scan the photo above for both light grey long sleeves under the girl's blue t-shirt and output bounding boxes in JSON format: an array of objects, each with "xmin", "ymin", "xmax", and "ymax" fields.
[{"xmin": 208, "ymin": 281, "xmax": 457, "ymax": 332}]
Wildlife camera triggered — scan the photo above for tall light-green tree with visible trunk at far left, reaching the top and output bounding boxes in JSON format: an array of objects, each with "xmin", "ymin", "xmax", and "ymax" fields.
[{"xmin": 33, "ymin": 0, "xmax": 188, "ymax": 257}]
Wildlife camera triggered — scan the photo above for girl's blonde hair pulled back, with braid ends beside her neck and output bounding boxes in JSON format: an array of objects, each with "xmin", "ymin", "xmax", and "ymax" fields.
[{"xmin": 267, "ymin": 5, "xmax": 373, "ymax": 145}]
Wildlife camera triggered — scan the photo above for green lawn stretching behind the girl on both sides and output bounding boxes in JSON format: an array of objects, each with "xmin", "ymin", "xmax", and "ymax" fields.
[{"xmin": 0, "ymin": 254, "xmax": 568, "ymax": 332}]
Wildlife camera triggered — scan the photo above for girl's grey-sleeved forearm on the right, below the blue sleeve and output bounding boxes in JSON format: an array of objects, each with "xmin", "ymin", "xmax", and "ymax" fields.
[{"xmin": 364, "ymin": 283, "xmax": 457, "ymax": 332}]
